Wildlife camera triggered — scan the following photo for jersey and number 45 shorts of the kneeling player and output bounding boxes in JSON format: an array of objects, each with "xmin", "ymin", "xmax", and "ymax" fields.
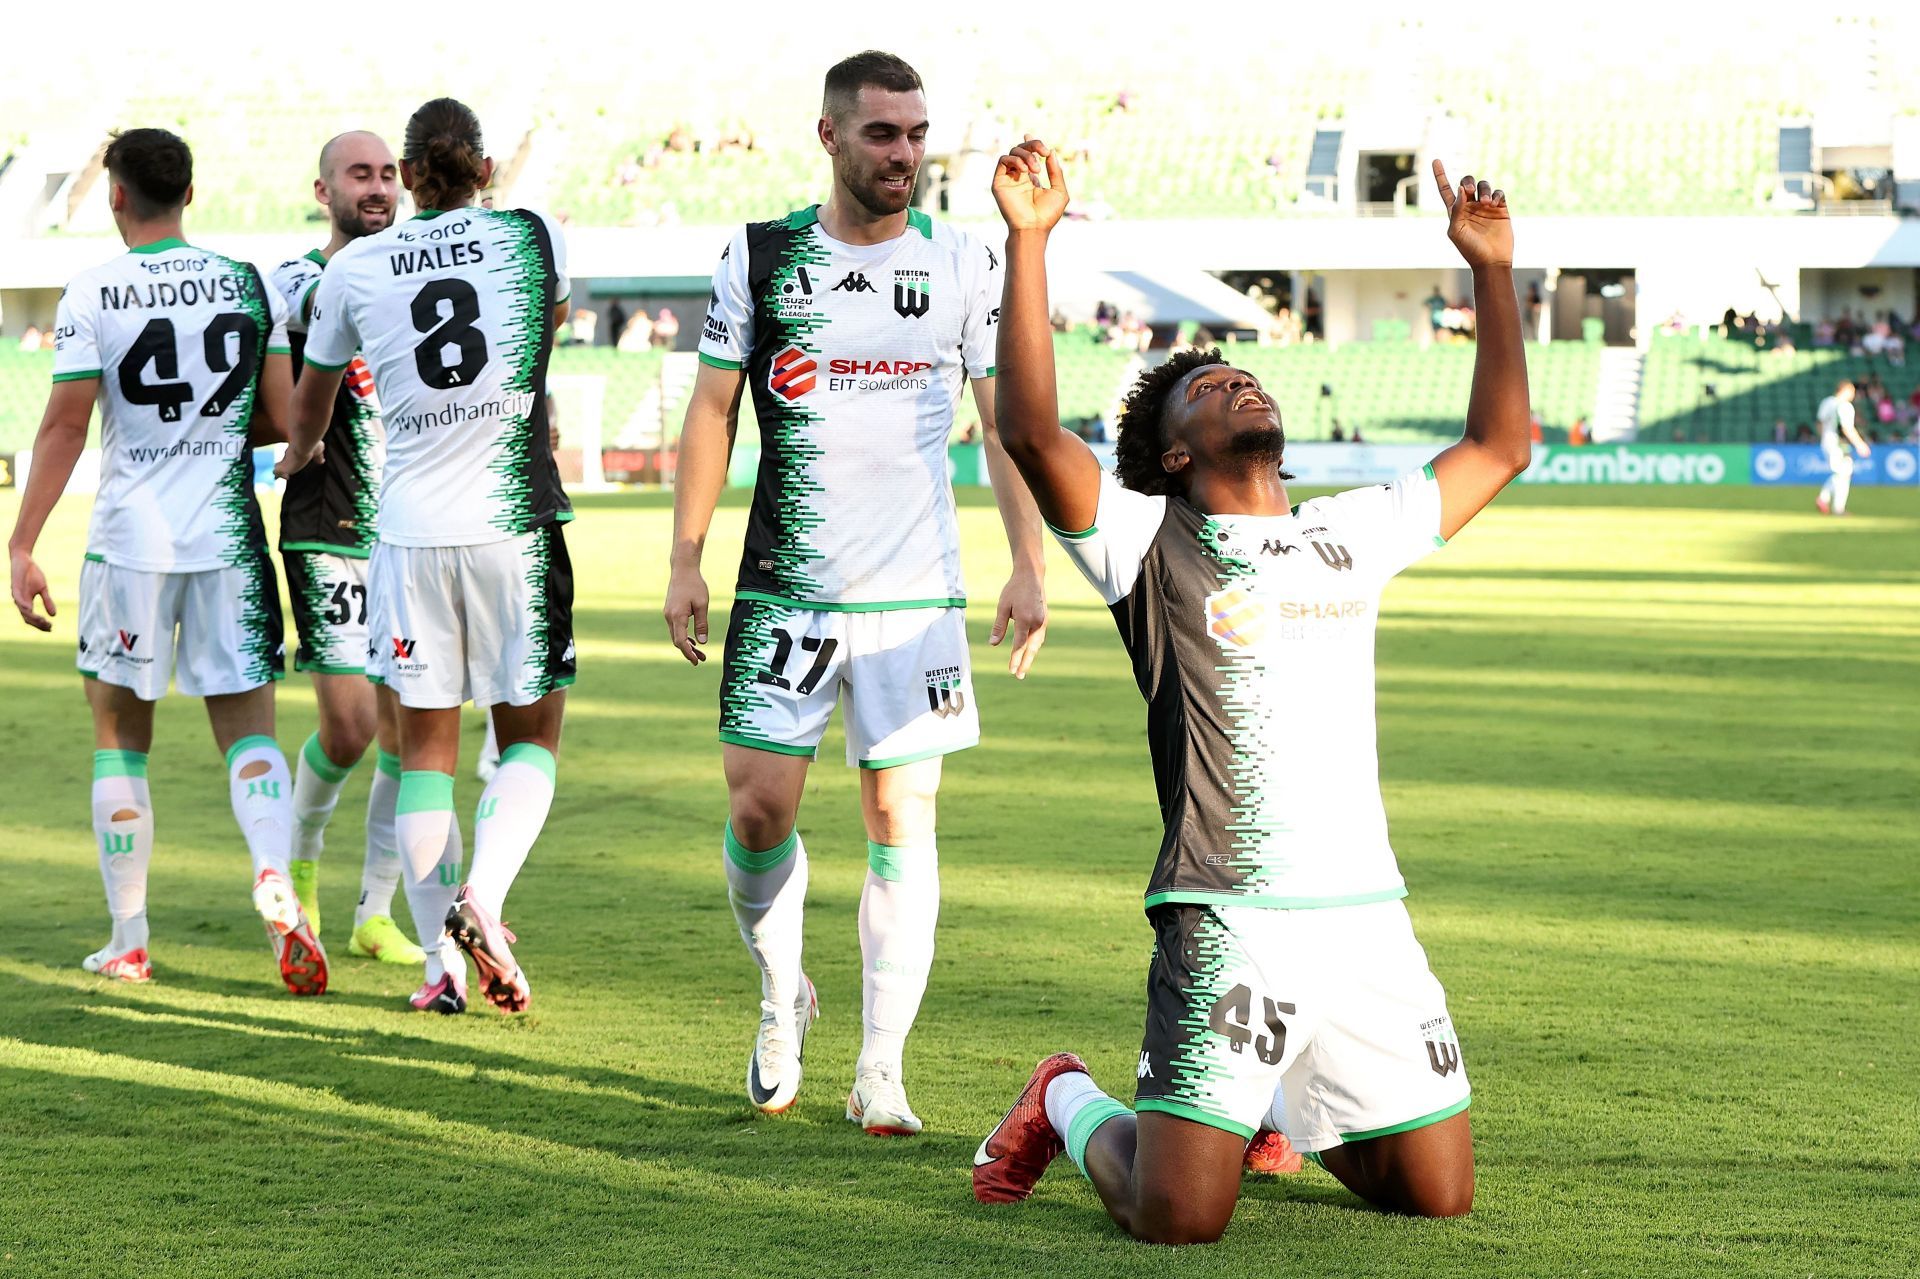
[{"xmin": 1056, "ymin": 467, "xmax": 1469, "ymax": 1150}]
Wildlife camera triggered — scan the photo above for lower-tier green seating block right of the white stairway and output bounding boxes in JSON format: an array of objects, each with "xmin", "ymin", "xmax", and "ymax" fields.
[{"xmin": 1640, "ymin": 334, "xmax": 1920, "ymax": 444}]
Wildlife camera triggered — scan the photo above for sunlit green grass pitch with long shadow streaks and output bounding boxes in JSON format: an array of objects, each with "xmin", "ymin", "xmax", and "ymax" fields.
[{"xmin": 0, "ymin": 480, "xmax": 1920, "ymax": 1279}]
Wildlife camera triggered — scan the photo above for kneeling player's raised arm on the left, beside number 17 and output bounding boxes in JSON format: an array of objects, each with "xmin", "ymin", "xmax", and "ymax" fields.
[{"xmin": 993, "ymin": 138, "xmax": 1100, "ymax": 532}]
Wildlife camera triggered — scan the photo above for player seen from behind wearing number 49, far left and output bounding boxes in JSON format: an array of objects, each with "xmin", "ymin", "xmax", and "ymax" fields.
[{"xmin": 8, "ymin": 129, "xmax": 326, "ymax": 995}]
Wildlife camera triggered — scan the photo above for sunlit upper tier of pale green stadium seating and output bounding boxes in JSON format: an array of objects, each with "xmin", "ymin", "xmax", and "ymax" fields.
[{"xmin": 11, "ymin": 13, "xmax": 1920, "ymax": 232}]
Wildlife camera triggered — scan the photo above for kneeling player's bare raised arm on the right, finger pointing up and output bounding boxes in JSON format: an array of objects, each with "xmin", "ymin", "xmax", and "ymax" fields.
[{"xmin": 1434, "ymin": 159, "xmax": 1532, "ymax": 538}]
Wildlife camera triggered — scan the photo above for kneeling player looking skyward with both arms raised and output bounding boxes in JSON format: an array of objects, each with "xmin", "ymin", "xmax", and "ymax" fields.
[{"xmin": 973, "ymin": 140, "xmax": 1528, "ymax": 1243}]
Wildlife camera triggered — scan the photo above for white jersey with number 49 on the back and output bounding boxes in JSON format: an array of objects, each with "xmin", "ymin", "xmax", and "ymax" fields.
[{"xmin": 54, "ymin": 240, "xmax": 288, "ymax": 572}]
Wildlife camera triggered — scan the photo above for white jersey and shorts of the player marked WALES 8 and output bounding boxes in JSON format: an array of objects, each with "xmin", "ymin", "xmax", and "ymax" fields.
[{"xmin": 305, "ymin": 207, "xmax": 574, "ymax": 709}]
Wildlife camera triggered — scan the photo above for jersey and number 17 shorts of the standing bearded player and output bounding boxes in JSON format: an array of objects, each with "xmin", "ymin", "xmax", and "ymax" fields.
[{"xmin": 701, "ymin": 207, "xmax": 1000, "ymax": 768}]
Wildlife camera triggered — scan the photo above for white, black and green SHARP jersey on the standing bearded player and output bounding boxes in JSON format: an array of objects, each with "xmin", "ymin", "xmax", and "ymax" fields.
[{"xmin": 701, "ymin": 207, "xmax": 1000, "ymax": 609}]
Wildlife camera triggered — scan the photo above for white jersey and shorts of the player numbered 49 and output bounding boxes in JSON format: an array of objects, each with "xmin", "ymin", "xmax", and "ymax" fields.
[{"xmin": 54, "ymin": 240, "xmax": 288, "ymax": 701}]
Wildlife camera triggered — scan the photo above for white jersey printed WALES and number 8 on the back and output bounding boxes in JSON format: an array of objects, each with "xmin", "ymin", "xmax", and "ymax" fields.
[{"xmin": 305, "ymin": 207, "xmax": 572, "ymax": 545}]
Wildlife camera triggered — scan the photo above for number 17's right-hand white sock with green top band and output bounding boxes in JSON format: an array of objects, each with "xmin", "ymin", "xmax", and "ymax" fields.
[{"xmin": 854, "ymin": 839, "xmax": 941, "ymax": 1074}]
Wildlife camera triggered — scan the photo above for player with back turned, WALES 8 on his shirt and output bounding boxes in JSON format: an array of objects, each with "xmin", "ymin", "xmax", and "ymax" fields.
[{"xmin": 278, "ymin": 98, "xmax": 574, "ymax": 1014}]
